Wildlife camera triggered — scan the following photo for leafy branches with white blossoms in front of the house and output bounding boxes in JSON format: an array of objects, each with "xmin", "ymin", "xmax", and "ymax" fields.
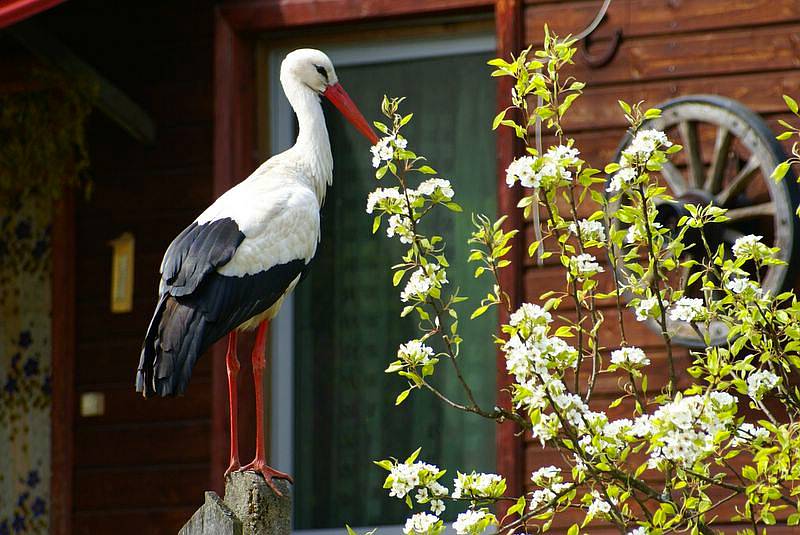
[{"xmin": 348, "ymin": 28, "xmax": 800, "ymax": 535}]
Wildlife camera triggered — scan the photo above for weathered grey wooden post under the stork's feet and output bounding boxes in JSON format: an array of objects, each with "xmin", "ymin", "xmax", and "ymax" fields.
[{"xmin": 178, "ymin": 472, "xmax": 292, "ymax": 535}]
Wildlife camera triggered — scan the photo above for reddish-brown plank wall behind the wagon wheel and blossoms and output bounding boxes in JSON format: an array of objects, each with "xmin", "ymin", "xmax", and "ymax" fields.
[{"xmin": 523, "ymin": 0, "xmax": 800, "ymax": 533}]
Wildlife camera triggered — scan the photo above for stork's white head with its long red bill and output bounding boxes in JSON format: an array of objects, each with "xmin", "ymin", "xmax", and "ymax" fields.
[{"xmin": 281, "ymin": 48, "xmax": 378, "ymax": 145}]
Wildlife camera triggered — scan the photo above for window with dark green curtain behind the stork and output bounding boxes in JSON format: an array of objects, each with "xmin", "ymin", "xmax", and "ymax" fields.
[{"xmin": 272, "ymin": 36, "xmax": 496, "ymax": 533}]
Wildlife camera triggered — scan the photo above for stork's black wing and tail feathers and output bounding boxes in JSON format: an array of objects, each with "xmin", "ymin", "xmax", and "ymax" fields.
[{"xmin": 136, "ymin": 219, "xmax": 307, "ymax": 396}]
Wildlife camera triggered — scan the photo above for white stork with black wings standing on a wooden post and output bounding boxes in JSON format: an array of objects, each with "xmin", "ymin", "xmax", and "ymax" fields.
[{"xmin": 136, "ymin": 49, "xmax": 377, "ymax": 492}]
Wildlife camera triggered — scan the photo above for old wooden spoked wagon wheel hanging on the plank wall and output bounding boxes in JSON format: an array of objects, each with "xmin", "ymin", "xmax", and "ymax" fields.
[{"xmin": 614, "ymin": 95, "xmax": 800, "ymax": 347}]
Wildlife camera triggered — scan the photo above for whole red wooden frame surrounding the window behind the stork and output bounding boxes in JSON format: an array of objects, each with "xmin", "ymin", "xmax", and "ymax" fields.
[{"xmin": 210, "ymin": 0, "xmax": 524, "ymax": 502}]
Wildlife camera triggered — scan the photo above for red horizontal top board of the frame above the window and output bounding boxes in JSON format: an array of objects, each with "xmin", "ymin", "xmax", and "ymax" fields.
[{"xmin": 220, "ymin": 0, "xmax": 492, "ymax": 31}]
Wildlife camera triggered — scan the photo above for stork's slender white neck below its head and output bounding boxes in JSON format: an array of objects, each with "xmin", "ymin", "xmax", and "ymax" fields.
[{"xmin": 282, "ymin": 80, "xmax": 333, "ymax": 205}]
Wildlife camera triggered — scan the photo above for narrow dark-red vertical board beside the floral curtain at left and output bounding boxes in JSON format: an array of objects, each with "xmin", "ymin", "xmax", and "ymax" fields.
[{"xmin": 50, "ymin": 194, "xmax": 75, "ymax": 535}]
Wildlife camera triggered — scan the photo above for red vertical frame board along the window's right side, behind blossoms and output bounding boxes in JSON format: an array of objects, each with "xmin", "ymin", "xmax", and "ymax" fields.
[{"xmin": 495, "ymin": 0, "xmax": 524, "ymax": 514}]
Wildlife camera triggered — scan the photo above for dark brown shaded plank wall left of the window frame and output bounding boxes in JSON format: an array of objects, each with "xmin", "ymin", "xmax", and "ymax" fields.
[{"xmin": 37, "ymin": 0, "xmax": 219, "ymax": 534}]
